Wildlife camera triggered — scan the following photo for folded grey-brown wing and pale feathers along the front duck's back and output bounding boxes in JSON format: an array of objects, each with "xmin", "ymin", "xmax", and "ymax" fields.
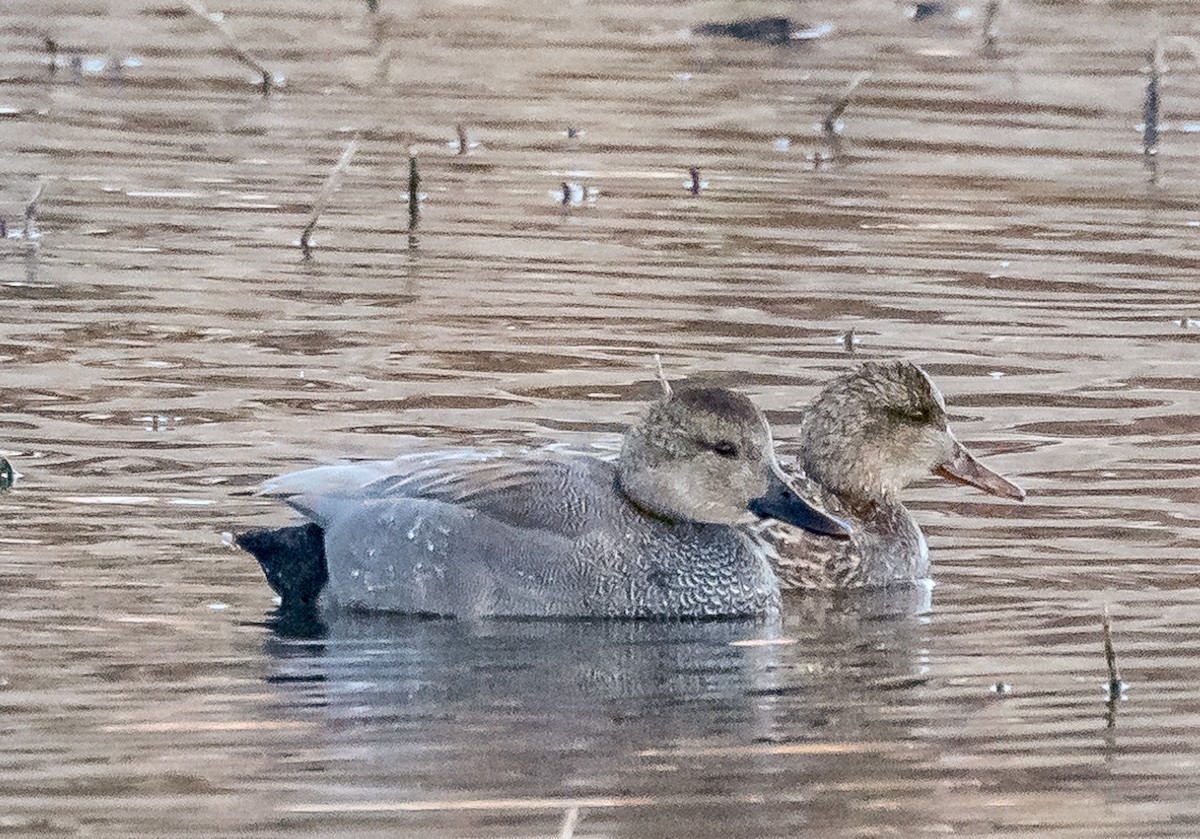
[{"xmin": 262, "ymin": 449, "xmax": 616, "ymax": 537}]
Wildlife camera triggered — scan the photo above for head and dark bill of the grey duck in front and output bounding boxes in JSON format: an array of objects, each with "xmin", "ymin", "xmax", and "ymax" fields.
[{"xmin": 617, "ymin": 388, "xmax": 850, "ymax": 538}]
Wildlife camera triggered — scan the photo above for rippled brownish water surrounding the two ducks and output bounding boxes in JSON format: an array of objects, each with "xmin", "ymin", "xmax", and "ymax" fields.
[{"xmin": 0, "ymin": 0, "xmax": 1200, "ymax": 838}]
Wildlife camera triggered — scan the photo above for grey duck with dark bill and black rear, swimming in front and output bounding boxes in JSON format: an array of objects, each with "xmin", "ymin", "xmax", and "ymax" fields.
[{"xmin": 238, "ymin": 388, "xmax": 847, "ymax": 618}]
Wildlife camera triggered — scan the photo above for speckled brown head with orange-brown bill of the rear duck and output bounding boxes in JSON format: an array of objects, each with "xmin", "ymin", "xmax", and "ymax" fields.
[{"xmin": 800, "ymin": 361, "xmax": 1025, "ymax": 503}]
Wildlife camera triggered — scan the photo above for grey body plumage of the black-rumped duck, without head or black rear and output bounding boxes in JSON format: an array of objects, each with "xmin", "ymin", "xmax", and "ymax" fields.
[{"xmin": 264, "ymin": 450, "xmax": 779, "ymax": 618}]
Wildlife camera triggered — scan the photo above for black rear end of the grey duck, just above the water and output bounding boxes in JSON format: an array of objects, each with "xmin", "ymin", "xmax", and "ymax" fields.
[{"xmin": 236, "ymin": 523, "xmax": 329, "ymax": 609}]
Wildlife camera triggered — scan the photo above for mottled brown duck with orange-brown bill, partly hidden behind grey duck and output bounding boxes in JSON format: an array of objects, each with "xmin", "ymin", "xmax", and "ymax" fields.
[{"xmin": 766, "ymin": 361, "xmax": 1025, "ymax": 591}]
